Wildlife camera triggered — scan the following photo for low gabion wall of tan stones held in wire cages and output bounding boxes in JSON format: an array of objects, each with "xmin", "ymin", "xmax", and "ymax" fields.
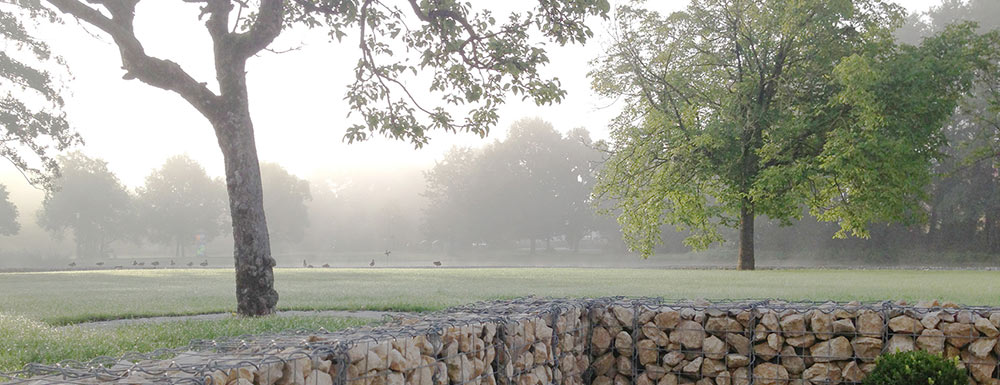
[{"xmin": 0, "ymin": 298, "xmax": 1000, "ymax": 385}]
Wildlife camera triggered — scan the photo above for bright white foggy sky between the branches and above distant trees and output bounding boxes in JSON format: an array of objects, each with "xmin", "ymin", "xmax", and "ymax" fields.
[{"xmin": 0, "ymin": 0, "xmax": 939, "ymax": 192}]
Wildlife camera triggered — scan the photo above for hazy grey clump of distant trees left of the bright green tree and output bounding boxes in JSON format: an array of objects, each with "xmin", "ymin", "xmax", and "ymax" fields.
[{"xmin": 422, "ymin": 118, "xmax": 617, "ymax": 253}]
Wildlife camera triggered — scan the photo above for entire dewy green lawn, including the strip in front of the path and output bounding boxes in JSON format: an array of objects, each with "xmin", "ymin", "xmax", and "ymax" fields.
[{"xmin": 0, "ymin": 268, "xmax": 1000, "ymax": 371}]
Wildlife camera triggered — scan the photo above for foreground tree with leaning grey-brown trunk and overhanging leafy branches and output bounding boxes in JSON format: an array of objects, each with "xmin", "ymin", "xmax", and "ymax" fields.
[{"xmin": 29, "ymin": 0, "xmax": 609, "ymax": 315}]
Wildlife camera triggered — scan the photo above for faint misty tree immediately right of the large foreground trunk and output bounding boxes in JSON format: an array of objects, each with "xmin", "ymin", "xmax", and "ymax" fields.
[{"xmin": 260, "ymin": 163, "xmax": 312, "ymax": 242}]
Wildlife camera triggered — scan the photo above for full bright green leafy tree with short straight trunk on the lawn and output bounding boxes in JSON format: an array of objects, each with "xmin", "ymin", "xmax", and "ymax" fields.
[{"xmin": 592, "ymin": 0, "xmax": 974, "ymax": 269}]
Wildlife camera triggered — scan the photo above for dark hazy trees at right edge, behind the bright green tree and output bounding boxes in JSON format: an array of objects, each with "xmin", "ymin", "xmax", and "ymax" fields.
[{"xmin": 897, "ymin": 0, "xmax": 1000, "ymax": 252}]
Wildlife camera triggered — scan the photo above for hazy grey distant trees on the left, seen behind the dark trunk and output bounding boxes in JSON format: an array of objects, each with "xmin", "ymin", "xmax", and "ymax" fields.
[{"xmin": 0, "ymin": 152, "xmax": 309, "ymax": 259}]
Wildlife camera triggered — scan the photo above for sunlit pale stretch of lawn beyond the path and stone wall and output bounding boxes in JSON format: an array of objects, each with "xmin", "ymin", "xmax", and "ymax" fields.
[{"xmin": 0, "ymin": 268, "xmax": 1000, "ymax": 325}]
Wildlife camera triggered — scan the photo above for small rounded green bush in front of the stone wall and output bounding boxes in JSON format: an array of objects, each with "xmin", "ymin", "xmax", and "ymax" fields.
[{"xmin": 864, "ymin": 351, "xmax": 969, "ymax": 385}]
